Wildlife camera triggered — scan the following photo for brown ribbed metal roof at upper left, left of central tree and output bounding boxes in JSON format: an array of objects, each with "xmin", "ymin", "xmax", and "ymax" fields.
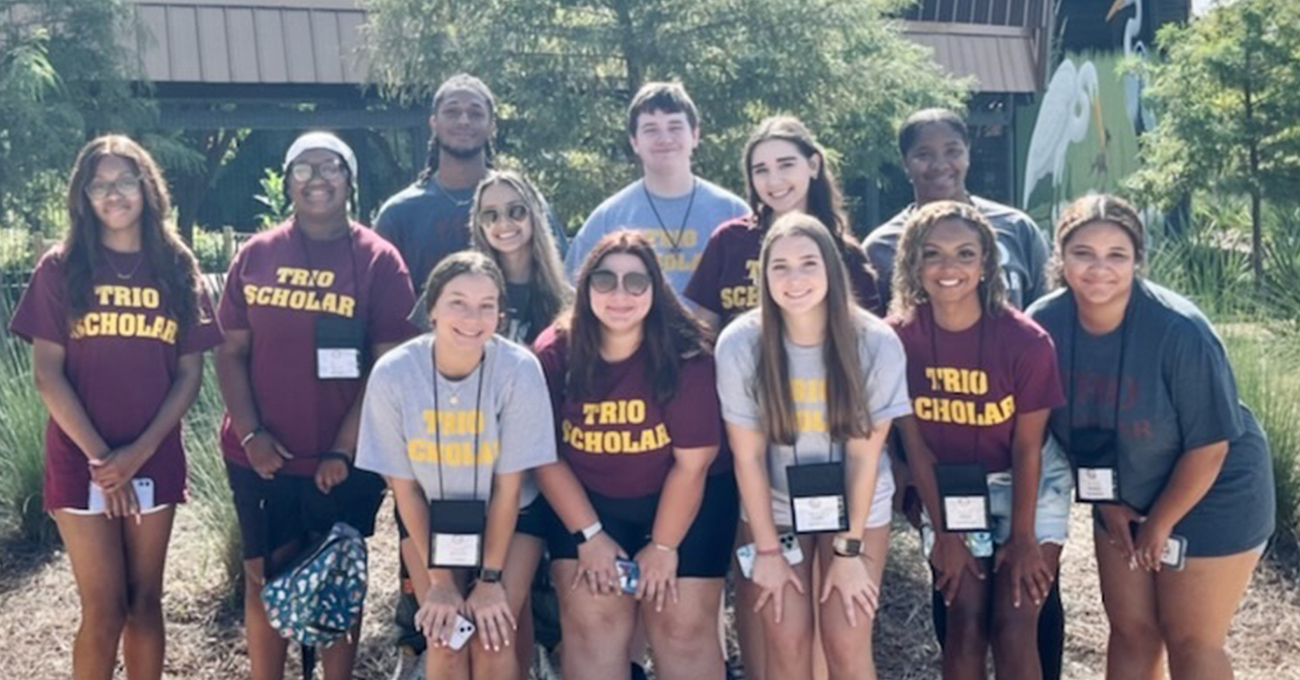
[{"xmin": 127, "ymin": 0, "xmax": 365, "ymax": 85}]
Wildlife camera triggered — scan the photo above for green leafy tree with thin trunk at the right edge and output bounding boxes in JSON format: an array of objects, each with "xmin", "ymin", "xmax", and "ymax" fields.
[{"xmin": 1128, "ymin": 0, "xmax": 1300, "ymax": 285}]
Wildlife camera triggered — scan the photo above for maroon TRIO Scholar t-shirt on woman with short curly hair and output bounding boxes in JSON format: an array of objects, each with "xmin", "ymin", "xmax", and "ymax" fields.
[{"xmin": 888, "ymin": 304, "xmax": 1065, "ymax": 472}]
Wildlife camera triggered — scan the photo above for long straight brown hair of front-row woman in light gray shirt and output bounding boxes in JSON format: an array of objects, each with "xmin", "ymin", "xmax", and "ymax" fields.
[{"xmin": 758, "ymin": 213, "xmax": 871, "ymax": 446}]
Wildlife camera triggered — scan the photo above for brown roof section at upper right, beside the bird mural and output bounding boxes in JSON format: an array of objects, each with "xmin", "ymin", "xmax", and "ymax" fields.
[{"xmin": 904, "ymin": 21, "xmax": 1039, "ymax": 94}]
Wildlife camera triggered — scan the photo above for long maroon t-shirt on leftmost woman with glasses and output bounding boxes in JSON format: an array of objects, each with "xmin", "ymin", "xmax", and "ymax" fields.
[{"xmin": 9, "ymin": 248, "xmax": 221, "ymax": 511}]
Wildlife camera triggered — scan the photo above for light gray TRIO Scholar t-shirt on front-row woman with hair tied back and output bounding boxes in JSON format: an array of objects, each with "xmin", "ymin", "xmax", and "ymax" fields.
[{"xmin": 356, "ymin": 334, "xmax": 555, "ymax": 507}]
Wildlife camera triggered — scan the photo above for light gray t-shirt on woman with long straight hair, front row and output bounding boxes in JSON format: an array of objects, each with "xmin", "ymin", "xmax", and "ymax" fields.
[{"xmin": 715, "ymin": 309, "xmax": 911, "ymax": 527}]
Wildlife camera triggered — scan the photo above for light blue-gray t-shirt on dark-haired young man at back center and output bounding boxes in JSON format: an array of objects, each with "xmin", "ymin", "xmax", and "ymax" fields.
[{"xmin": 564, "ymin": 177, "xmax": 749, "ymax": 295}]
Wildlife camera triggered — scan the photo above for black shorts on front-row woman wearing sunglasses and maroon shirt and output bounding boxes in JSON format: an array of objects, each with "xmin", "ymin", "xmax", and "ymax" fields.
[{"xmin": 547, "ymin": 471, "xmax": 740, "ymax": 579}]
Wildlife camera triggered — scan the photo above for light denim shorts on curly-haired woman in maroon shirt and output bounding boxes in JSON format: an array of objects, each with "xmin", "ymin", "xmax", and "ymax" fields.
[{"xmin": 920, "ymin": 437, "xmax": 1074, "ymax": 558}]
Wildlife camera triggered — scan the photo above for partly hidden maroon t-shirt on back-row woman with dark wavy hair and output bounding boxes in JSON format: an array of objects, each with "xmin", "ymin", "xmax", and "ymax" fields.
[{"xmin": 684, "ymin": 217, "xmax": 884, "ymax": 326}]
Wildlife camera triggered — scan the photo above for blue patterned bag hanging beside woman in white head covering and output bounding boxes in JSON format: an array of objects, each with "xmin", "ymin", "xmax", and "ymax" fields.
[{"xmin": 261, "ymin": 521, "xmax": 367, "ymax": 650}]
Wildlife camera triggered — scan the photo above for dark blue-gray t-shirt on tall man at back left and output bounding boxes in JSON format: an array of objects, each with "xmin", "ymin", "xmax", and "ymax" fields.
[{"xmin": 374, "ymin": 179, "xmax": 567, "ymax": 295}]
